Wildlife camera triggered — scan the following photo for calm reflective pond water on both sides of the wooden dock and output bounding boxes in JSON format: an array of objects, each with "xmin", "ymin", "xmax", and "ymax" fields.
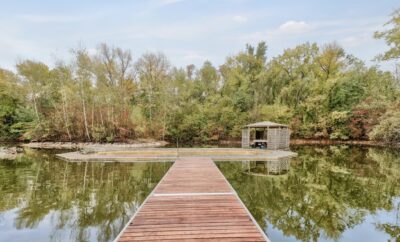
[{"xmin": 0, "ymin": 146, "xmax": 400, "ymax": 242}]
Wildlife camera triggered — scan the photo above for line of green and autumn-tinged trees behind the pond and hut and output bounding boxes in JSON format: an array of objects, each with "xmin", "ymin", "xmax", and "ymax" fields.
[{"xmin": 0, "ymin": 10, "xmax": 400, "ymax": 142}]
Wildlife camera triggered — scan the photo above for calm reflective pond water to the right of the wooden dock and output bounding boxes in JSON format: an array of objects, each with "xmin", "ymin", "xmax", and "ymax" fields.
[{"xmin": 217, "ymin": 146, "xmax": 400, "ymax": 242}]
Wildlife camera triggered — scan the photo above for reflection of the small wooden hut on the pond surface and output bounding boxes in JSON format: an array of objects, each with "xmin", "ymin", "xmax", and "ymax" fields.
[{"xmin": 242, "ymin": 158, "xmax": 290, "ymax": 176}]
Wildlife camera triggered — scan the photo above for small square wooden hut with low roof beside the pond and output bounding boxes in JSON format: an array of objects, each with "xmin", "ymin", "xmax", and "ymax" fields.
[{"xmin": 242, "ymin": 121, "xmax": 290, "ymax": 150}]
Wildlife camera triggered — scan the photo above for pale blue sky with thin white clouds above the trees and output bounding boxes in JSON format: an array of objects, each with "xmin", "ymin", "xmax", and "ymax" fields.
[{"xmin": 0, "ymin": 0, "xmax": 400, "ymax": 70}]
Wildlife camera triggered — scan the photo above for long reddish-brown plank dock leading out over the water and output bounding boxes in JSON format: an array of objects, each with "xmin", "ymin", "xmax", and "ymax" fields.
[{"xmin": 115, "ymin": 157, "xmax": 269, "ymax": 241}]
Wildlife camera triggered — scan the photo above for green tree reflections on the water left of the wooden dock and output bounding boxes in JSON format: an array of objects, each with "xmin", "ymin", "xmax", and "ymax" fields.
[{"xmin": 0, "ymin": 149, "xmax": 170, "ymax": 241}]
